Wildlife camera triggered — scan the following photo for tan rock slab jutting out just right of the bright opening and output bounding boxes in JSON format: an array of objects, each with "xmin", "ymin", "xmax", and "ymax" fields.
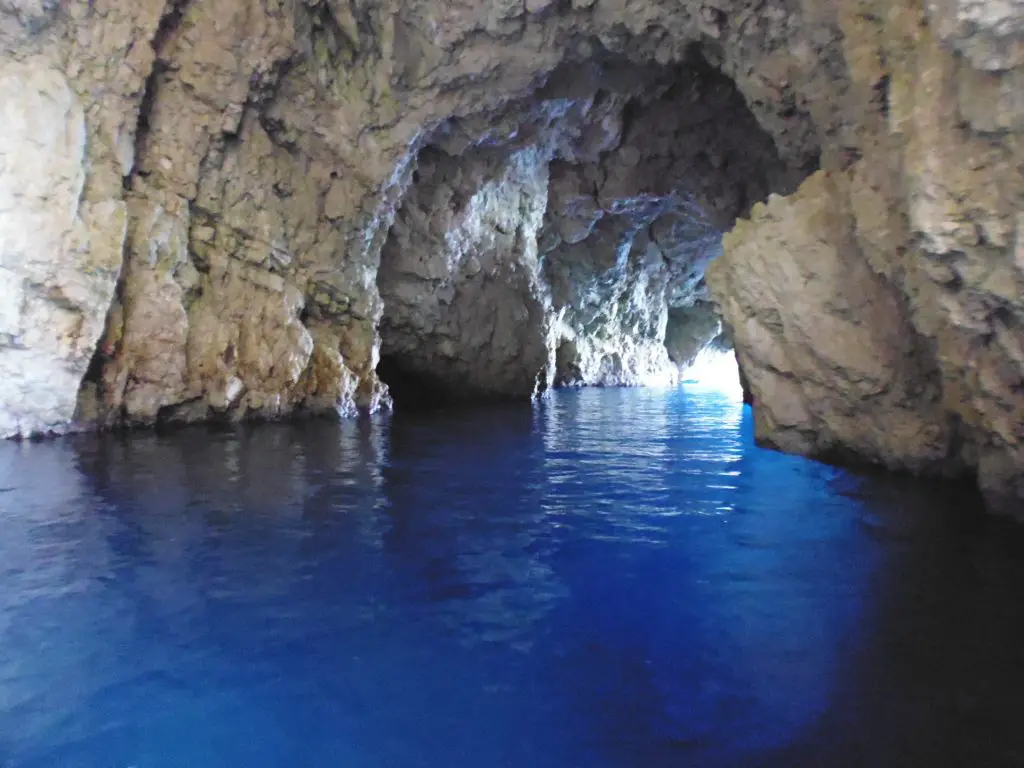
[{"xmin": 708, "ymin": 171, "xmax": 955, "ymax": 470}]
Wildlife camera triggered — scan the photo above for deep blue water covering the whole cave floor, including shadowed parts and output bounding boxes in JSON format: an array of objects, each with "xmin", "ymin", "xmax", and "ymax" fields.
[{"xmin": 0, "ymin": 389, "xmax": 1024, "ymax": 768}]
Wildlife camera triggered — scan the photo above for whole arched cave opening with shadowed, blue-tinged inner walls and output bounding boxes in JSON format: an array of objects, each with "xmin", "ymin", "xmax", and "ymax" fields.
[{"xmin": 378, "ymin": 47, "xmax": 807, "ymax": 408}]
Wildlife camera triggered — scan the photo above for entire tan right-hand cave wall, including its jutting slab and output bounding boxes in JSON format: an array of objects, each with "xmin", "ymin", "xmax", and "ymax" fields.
[{"xmin": 708, "ymin": 1, "xmax": 1024, "ymax": 514}]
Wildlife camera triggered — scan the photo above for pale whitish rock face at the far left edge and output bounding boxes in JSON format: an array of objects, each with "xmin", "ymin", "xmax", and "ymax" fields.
[{"xmin": 0, "ymin": 58, "xmax": 126, "ymax": 437}]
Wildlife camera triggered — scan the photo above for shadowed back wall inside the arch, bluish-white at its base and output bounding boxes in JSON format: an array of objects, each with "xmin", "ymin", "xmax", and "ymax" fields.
[{"xmin": 541, "ymin": 58, "xmax": 803, "ymax": 385}]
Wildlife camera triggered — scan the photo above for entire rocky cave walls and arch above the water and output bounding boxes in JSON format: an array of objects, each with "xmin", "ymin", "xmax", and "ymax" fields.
[{"xmin": 0, "ymin": 0, "xmax": 1024, "ymax": 518}]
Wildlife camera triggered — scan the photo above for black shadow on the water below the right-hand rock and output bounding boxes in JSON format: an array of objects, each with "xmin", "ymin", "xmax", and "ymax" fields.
[{"xmin": 756, "ymin": 472, "xmax": 1024, "ymax": 768}]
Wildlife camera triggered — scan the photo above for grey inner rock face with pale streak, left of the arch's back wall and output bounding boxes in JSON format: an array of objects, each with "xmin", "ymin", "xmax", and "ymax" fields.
[{"xmin": 378, "ymin": 150, "xmax": 551, "ymax": 396}]
